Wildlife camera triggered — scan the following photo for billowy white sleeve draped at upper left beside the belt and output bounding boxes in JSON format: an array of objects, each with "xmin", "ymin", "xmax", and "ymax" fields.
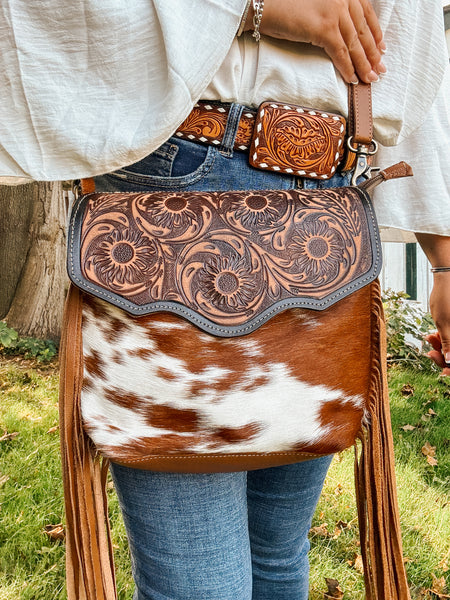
[{"xmin": 0, "ymin": 0, "xmax": 246, "ymax": 183}]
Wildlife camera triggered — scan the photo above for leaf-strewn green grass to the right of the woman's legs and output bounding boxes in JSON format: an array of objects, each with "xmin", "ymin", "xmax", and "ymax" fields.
[{"xmin": 311, "ymin": 367, "xmax": 450, "ymax": 600}]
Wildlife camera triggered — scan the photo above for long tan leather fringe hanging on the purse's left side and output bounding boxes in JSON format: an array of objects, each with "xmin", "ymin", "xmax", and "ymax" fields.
[{"xmin": 59, "ymin": 285, "xmax": 117, "ymax": 600}]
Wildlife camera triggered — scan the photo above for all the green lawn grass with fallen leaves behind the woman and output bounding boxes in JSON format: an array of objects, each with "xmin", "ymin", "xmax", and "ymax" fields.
[{"xmin": 0, "ymin": 360, "xmax": 450, "ymax": 600}]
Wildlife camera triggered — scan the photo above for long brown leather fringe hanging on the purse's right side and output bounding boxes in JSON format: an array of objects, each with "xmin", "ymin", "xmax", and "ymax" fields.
[{"xmin": 355, "ymin": 282, "xmax": 411, "ymax": 600}]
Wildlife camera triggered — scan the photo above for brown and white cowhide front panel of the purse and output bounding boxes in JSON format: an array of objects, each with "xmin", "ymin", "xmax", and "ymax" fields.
[{"xmin": 81, "ymin": 284, "xmax": 376, "ymax": 468}]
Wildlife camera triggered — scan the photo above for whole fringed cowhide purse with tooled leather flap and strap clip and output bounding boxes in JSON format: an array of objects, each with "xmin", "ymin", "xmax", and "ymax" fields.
[{"xmin": 60, "ymin": 86, "xmax": 412, "ymax": 600}]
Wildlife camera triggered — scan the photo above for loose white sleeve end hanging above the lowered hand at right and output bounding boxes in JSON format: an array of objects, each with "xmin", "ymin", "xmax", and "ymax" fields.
[{"xmin": 374, "ymin": 62, "xmax": 450, "ymax": 241}]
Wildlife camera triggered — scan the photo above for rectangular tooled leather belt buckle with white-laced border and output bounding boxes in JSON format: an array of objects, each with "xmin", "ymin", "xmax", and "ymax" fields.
[{"xmin": 249, "ymin": 102, "xmax": 346, "ymax": 179}]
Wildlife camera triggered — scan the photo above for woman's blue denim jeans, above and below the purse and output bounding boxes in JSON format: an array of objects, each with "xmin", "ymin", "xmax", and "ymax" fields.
[{"xmin": 96, "ymin": 105, "xmax": 349, "ymax": 600}]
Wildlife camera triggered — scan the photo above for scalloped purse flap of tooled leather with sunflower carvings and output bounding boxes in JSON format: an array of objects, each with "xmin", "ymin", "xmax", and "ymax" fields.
[{"xmin": 68, "ymin": 188, "xmax": 381, "ymax": 337}]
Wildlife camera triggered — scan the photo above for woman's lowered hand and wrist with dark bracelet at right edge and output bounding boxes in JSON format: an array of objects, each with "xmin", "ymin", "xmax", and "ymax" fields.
[{"xmin": 416, "ymin": 233, "xmax": 450, "ymax": 376}]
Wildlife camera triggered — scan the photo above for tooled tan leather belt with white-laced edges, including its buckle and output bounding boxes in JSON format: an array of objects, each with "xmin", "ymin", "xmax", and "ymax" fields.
[{"xmin": 175, "ymin": 101, "xmax": 355, "ymax": 179}]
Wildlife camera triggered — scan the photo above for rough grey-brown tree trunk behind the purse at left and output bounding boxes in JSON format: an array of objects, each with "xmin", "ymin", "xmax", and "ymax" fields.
[{"xmin": 0, "ymin": 182, "xmax": 67, "ymax": 340}]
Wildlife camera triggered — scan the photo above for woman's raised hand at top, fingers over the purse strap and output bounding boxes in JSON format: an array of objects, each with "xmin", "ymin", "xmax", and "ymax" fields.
[{"xmin": 245, "ymin": 0, "xmax": 386, "ymax": 83}]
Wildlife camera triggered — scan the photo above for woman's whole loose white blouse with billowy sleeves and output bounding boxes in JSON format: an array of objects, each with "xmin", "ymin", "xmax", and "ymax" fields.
[{"xmin": 0, "ymin": 0, "xmax": 450, "ymax": 235}]
